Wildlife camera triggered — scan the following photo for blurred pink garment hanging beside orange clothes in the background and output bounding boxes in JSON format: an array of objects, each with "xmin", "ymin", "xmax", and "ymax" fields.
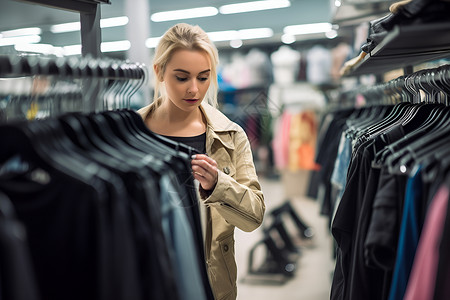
[{"xmin": 272, "ymin": 111, "xmax": 291, "ymax": 170}]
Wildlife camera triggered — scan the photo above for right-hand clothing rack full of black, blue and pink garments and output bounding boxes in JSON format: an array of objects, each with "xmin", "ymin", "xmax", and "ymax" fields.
[{"xmin": 318, "ymin": 61, "xmax": 450, "ymax": 300}]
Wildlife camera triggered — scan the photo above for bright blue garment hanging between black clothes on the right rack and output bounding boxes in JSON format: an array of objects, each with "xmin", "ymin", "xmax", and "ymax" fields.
[{"xmin": 388, "ymin": 168, "xmax": 423, "ymax": 300}]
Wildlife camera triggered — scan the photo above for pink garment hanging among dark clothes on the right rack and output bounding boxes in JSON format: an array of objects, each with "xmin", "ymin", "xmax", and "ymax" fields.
[{"xmin": 404, "ymin": 185, "xmax": 449, "ymax": 300}]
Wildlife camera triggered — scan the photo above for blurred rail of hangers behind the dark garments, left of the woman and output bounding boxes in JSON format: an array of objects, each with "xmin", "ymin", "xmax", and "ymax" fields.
[{"xmin": 0, "ymin": 55, "xmax": 148, "ymax": 119}]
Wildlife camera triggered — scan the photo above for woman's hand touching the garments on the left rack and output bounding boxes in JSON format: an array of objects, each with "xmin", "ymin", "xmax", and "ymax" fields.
[{"xmin": 191, "ymin": 154, "xmax": 218, "ymax": 191}]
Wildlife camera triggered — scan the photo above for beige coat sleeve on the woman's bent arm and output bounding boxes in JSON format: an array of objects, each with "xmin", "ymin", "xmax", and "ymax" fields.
[{"xmin": 200, "ymin": 129, "xmax": 266, "ymax": 232}]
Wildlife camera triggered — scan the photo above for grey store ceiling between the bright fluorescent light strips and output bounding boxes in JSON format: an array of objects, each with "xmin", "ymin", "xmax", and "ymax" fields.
[{"xmin": 0, "ymin": 0, "xmax": 394, "ymax": 53}]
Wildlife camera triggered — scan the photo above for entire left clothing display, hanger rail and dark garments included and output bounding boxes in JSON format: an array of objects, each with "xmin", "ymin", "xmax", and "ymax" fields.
[{"xmin": 0, "ymin": 56, "xmax": 213, "ymax": 300}]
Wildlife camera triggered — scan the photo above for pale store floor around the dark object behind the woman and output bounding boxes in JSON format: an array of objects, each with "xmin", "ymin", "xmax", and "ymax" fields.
[{"xmin": 235, "ymin": 178, "xmax": 334, "ymax": 300}]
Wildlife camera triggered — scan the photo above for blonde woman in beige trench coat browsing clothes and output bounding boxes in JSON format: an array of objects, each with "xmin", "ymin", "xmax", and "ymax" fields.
[{"xmin": 139, "ymin": 24, "xmax": 265, "ymax": 299}]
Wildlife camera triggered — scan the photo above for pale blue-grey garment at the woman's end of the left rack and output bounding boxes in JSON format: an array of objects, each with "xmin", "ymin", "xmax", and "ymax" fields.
[{"xmin": 160, "ymin": 175, "xmax": 206, "ymax": 300}]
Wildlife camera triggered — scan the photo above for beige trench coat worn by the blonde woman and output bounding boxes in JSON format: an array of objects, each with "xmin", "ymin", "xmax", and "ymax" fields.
[{"xmin": 138, "ymin": 103, "xmax": 265, "ymax": 300}]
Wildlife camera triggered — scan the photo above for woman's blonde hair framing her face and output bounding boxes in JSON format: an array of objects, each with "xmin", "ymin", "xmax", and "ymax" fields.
[{"xmin": 153, "ymin": 23, "xmax": 219, "ymax": 107}]
